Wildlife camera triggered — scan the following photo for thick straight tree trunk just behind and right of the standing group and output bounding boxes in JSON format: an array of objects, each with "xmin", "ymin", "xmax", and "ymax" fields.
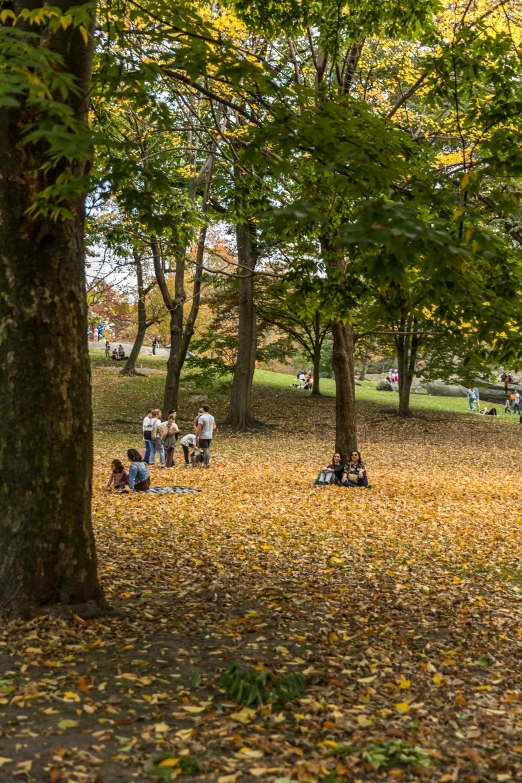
[{"xmin": 225, "ymin": 223, "xmax": 262, "ymax": 430}]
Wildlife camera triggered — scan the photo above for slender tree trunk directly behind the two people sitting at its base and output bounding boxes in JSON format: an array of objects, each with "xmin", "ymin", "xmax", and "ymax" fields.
[{"xmin": 321, "ymin": 236, "xmax": 357, "ymax": 457}]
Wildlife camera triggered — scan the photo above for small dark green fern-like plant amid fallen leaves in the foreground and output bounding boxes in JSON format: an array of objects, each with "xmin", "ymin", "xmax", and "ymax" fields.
[{"xmin": 218, "ymin": 663, "xmax": 306, "ymax": 707}]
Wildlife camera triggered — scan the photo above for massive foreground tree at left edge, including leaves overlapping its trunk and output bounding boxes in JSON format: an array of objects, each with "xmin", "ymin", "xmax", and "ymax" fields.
[{"xmin": 0, "ymin": 0, "xmax": 102, "ymax": 616}]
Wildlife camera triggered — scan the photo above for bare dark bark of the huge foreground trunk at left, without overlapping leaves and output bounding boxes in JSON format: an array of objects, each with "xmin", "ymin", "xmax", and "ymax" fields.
[{"xmin": 0, "ymin": 0, "xmax": 103, "ymax": 617}]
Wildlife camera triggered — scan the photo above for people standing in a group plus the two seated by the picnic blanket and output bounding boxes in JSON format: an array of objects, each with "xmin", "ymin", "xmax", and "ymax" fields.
[{"xmin": 107, "ymin": 404, "xmax": 216, "ymax": 492}]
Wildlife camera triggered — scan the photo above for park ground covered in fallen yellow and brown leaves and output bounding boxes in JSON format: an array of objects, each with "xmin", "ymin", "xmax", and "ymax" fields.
[{"xmin": 0, "ymin": 369, "xmax": 522, "ymax": 783}]
